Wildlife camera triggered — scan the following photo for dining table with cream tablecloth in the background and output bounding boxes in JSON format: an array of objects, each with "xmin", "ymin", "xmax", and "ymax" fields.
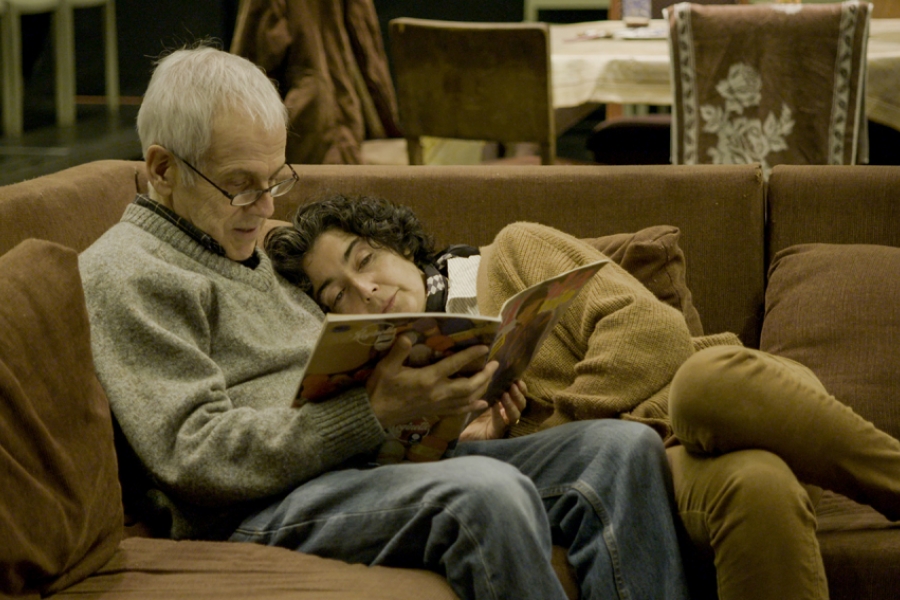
[{"xmin": 550, "ymin": 18, "xmax": 900, "ymax": 130}]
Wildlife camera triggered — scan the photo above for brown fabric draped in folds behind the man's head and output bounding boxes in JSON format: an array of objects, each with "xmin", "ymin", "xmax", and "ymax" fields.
[{"xmin": 231, "ymin": 0, "xmax": 401, "ymax": 164}]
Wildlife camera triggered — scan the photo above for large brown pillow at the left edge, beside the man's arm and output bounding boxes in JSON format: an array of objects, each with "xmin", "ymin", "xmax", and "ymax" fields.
[{"xmin": 0, "ymin": 240, "xmax": 122, "ymax": 596}]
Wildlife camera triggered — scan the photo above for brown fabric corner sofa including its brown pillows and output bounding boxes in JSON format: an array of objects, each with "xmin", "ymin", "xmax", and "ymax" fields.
[{"xmin": 0, "ymin": 161, "xmax": 900, "ymax": 600}]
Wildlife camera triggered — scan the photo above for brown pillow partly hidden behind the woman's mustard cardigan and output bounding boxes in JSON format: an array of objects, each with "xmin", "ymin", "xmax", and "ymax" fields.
[{"xmin": 585, "ymin": 225, "xmax": 703, "ymax": 336}]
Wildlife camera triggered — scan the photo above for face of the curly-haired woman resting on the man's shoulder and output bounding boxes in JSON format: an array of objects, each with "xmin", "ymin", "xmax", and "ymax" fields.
[{"xmin": 303, "ymin": 229, "xmax": 425, "ymax": 314}]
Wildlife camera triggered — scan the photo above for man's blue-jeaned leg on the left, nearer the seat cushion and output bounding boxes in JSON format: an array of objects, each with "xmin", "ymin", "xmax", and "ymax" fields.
[{"xmin": 231, "ymin": 457, "xmax": 566, "ymax": 600}]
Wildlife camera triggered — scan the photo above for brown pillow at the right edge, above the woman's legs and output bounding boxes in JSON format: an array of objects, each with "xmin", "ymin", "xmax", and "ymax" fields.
[{"xmin": 760, "ymin": 244, "xmax": 900, "ymax": 437}]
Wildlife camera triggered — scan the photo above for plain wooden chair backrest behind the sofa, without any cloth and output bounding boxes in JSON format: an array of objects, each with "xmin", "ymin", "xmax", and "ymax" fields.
[{"xmin": 390, "ymin": 18, "xmax": 556, "ymax": 164}]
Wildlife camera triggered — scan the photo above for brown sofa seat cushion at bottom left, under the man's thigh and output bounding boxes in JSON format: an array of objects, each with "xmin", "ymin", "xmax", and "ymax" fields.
[{"xmin": 54, "ymin": 538, "xmax": 457, "ymax": 600}]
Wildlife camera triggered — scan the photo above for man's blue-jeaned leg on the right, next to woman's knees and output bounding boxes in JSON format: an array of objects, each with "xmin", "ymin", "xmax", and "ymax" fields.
[{"xmin": 456, "ymin": 419, "xmax": 687, "ymax": 600}]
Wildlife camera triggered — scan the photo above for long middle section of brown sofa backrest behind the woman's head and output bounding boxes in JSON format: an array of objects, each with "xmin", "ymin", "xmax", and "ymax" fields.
[{"xmin": 275, "ymin": 165, "xmax": 764, "ymax": 347}]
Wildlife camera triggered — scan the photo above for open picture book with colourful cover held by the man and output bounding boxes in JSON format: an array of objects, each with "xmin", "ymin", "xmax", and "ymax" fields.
[{"xmin": 295, "ymin": 259, "xmax": 609, "ymax": 462}]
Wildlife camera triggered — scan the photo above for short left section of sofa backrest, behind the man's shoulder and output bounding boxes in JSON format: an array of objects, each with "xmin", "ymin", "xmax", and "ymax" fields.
[{"xmin": 0, "ymin": 160, "xmax": 147, "ymax": 254}]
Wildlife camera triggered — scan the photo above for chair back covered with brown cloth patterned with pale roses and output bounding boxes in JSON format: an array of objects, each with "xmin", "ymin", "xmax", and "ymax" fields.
[{"xmin": 667, "ymin": 1, "xmax": 871, "ymax": 177}]
